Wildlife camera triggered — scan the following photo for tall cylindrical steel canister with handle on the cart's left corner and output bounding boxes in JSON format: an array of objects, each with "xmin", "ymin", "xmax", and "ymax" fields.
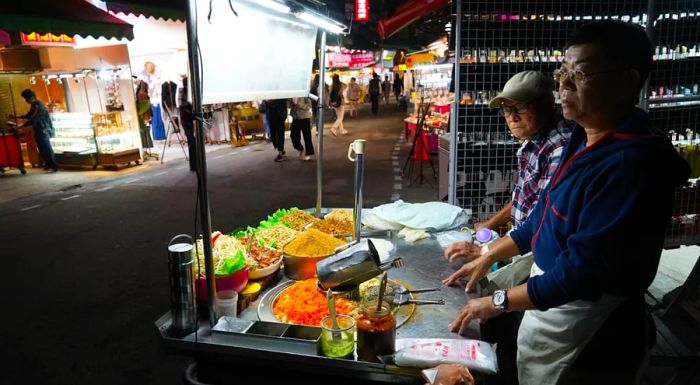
[{"xmin": 168, "ymin": 234, "xmax": 197, "ymax": 335}]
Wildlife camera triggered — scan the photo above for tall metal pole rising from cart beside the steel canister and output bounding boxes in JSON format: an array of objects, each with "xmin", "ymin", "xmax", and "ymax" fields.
[{"xmin": 187, "ymin": 0, "xmax": 218, "ymax": 328}]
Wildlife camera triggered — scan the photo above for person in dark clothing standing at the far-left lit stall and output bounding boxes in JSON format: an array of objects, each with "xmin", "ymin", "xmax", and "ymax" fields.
[{"xmin": 10, "ymin": 88, "xmax": 58, "ymax": 173}]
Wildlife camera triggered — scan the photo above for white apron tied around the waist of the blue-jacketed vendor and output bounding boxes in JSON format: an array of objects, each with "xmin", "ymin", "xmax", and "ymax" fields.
[{"xmin": 517, "ymin": 263, "xmax": 624, "ymax": 385}]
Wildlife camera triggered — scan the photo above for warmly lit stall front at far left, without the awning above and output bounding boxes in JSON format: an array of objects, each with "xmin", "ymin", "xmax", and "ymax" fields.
[{"xmin": 0, "ymin": 41, "xmax": 141, "ymax": 169}]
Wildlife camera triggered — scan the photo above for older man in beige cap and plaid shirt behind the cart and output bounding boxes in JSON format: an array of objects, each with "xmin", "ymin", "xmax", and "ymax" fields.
[{"xmin": 443, "ymin": 71, "xmax": 571, "ymax": 291}]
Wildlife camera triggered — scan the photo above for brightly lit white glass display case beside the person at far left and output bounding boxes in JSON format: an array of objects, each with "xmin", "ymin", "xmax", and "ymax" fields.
[{"xmin": 51, "ymin": 112, "xmax": 97, "ymax": 168}]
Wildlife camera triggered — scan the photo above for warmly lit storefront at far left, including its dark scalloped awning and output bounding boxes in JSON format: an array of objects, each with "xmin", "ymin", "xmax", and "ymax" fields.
[{"xmin": 0, "ymin": 0, "xmax": 141, "ymax": 168}]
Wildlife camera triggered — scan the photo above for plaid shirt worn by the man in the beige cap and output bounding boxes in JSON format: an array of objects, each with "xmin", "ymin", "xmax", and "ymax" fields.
[{"xmin": 510, "ymin": 122, "xmax": 571, "ymax": 228}]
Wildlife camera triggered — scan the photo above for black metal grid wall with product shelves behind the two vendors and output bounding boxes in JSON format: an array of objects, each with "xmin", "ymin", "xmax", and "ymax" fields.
[{"xmin": 455, "ymin": 0, "xmax": 700, "ymax": 246}]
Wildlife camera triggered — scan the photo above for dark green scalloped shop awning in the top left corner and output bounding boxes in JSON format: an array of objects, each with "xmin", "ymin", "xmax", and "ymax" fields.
[{"xmin": 0, "ymin": 0, "xmax": 134, "ymax": 39}]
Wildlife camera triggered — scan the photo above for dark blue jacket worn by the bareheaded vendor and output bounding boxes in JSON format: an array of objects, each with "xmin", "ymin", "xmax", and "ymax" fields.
[{"xmin": 511, "ymin": 109, "xmax": 690, "ymax": 310}]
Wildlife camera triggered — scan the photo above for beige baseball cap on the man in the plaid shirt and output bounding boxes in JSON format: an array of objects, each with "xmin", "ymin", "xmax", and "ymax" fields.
[{"xmin": 489, "ymin": 71, "xmax": 555, "ymax": 108}]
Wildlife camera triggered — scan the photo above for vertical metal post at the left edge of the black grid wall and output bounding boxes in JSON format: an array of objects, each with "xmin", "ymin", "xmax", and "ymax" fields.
[{"xmin": 452, "ymin": 1, "xmax": 466, "ymax": 205}]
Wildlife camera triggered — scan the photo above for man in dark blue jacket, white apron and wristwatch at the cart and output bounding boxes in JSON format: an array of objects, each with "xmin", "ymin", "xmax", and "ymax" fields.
[{"xmin": 449, "ymin": 20, "xmax": 690, "ymax": 385}]
